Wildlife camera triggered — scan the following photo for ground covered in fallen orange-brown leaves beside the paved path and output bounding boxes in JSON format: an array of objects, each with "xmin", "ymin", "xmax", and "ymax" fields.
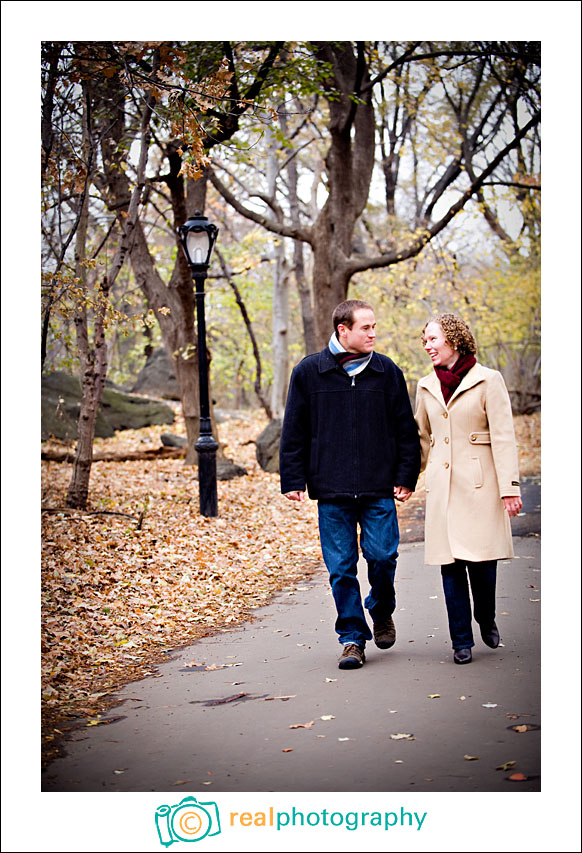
[{"xmin": 42, "ymin": 413, "xmax": 540, "ymax": 757}]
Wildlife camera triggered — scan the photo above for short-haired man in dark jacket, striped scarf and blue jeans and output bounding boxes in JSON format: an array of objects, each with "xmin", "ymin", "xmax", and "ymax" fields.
[{"xmin": 280, "ymin": 299, "xmax": 420, "ymax": 669}]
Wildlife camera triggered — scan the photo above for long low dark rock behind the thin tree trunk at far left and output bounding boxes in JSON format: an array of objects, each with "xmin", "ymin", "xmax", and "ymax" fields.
[{"xmin": 41, "ymin": 371, "xmax": 174, "ymax": 441}]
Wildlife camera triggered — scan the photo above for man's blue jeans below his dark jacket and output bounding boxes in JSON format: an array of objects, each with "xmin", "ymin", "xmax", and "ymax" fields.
[{"xmin": 318, "ymin": 498, "xmax": 399, "ymax": 648}]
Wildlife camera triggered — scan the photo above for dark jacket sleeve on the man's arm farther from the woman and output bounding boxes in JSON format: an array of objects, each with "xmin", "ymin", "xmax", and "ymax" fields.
[{"xmin": 279, "ymin": 365, "xmax": 310, "ymax": 494}]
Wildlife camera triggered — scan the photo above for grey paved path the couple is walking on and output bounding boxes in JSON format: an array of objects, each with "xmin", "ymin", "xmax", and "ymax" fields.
[{"xmin": 42, "ymin": 520, "xmax": 541, "ymax": 794}]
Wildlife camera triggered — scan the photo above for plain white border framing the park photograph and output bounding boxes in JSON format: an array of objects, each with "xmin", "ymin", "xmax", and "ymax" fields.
[{"xmin": 1, "ymin": 2, "xmax": 580, "ymax": 851}]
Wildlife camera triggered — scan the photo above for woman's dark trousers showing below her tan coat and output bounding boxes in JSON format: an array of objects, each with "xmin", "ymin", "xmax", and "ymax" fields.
[{"xmin": 441, "ymin": 560, "xmax": 497, "ymax": 649}]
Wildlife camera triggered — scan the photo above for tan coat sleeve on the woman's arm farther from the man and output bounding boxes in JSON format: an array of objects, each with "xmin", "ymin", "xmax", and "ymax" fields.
[{"xmin": 485, "ymin": 371, "xmax": 521, "ymax": 498}]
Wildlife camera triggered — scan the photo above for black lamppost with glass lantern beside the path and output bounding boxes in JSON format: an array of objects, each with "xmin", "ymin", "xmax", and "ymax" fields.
[{"xmin": 178, "ymin": 210, "xmax": 218, "ymax": 517}]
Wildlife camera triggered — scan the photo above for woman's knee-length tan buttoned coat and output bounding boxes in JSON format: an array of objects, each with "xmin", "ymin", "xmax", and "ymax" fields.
[{"xmin": 415, "ymin": 364, "xmax": 520, "ymax": 565}]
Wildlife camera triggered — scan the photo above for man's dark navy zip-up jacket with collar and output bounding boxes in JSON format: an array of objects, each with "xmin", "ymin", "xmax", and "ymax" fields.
[{"xmin": 279, "ymin": 348, "xmax": 420, "ymax": 500}]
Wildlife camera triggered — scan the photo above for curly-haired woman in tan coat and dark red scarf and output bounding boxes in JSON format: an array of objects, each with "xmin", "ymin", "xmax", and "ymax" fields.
[{"xmin": 415, "ymin": 314, "xmax": 522, "ymax": 664}]
